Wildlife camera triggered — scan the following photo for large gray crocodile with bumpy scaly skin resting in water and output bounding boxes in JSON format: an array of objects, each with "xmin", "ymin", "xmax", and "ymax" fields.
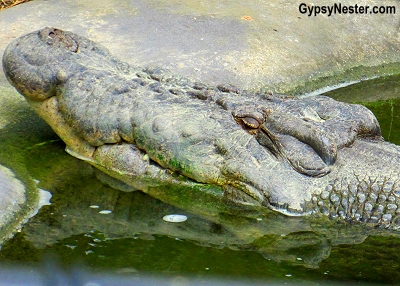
[{"xmin": 3, "ymin": 28, "xmax": 400, "ymax": 228}]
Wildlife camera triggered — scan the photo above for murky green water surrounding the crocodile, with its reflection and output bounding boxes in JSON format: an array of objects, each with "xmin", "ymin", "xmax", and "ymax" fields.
[{"xmin": 0, "ymin": 77, "xmax": 400, "ymax": 284}]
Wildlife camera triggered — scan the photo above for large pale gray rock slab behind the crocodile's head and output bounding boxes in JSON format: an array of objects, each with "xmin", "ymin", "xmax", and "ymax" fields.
[{"xmin": 0, "ymin": 0, "xmax": 400, "ymax": 92}]
